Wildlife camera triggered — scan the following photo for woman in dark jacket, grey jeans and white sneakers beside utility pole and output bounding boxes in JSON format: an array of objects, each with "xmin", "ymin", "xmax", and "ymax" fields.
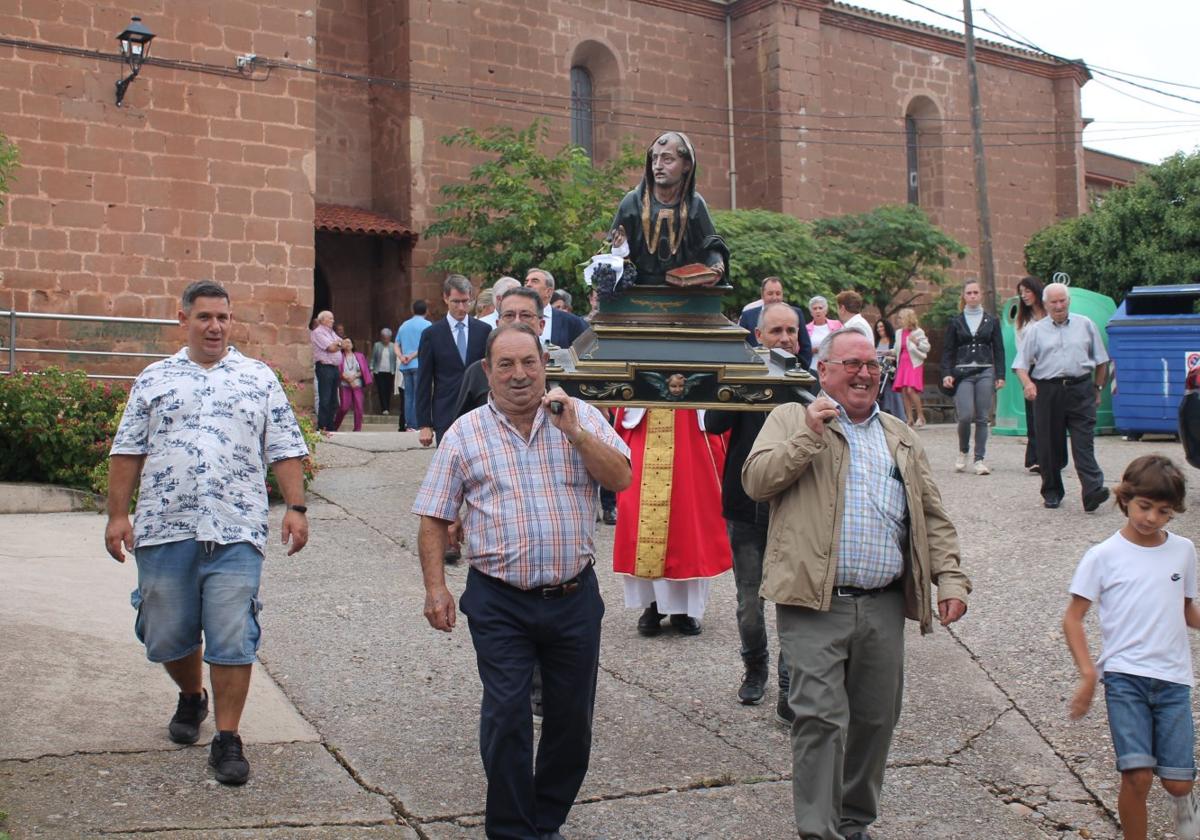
[{"xmin": 942, "ymin": 280, "xmax": 1006, "ymax": 475}]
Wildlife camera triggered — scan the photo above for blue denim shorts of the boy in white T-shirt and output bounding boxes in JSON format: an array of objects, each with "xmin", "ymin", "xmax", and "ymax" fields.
[{"xmin": 1104, "ymin": 672, "xmax": 1196, "ymax": 781}]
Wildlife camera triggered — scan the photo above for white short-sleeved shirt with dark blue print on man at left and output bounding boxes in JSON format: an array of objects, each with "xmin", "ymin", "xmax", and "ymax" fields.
[{"xmin": 110, "ymin": 347, "xmax": 308, "ymax": 551}]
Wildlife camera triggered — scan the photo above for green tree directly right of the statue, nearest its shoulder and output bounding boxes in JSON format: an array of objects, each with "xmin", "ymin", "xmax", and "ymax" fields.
[{"xmin": 713, "ymin": 210, "xmax": 833, "ymax": 308}]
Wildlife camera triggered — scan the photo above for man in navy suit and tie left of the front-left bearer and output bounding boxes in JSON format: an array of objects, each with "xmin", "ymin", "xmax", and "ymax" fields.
[{"xmin": 416, "ymin": 274, "xmax": 492, "ymax": 446}]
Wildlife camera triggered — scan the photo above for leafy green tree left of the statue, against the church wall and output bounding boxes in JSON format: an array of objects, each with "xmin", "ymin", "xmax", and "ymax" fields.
[{"xmin": 425, "ymin": 120, "xmax": 642, "ymax": 293}]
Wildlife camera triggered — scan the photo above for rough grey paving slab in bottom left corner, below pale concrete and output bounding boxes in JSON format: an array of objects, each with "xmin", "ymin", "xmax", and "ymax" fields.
[{"xmin": 0, "ymin": 744, "xmax": 396, "ymax": 840}]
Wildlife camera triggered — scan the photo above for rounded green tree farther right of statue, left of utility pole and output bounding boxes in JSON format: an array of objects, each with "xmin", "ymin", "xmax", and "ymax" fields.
[{"xmin": 812, "ymin": 204, "xmax": 967, "ymax": 318}]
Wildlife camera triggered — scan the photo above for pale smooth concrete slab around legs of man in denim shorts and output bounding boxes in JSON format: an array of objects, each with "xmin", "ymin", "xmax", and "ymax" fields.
[{"xmin": 0, "ymin": 514, "xmax": 319, "ymax": 758}]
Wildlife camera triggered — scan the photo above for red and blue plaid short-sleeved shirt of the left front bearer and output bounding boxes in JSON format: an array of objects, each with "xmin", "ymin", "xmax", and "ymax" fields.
[{"xmin": 413, "ymin": 397, "xmax": 629, "ymax": 589}]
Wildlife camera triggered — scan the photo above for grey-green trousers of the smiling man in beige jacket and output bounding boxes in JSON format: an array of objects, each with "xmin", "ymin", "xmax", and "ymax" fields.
[{"xmin": 775, "ymin": 589, "xmax": 904, "ymax": 840}]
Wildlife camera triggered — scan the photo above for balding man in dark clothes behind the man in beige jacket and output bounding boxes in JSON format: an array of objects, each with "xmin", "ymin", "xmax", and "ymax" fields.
[{"xmin": 704, "ymin": 302, "xmax": 800, "ymax": 724}]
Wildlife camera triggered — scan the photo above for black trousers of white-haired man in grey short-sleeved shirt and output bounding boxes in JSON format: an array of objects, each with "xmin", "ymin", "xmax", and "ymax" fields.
[{"xmin": 1033, "ymin": 377, "xmax": 1104, "ymax": 502}]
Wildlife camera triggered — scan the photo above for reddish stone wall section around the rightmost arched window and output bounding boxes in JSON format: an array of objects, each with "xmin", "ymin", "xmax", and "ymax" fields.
[{"xmin": 818, "ymin": 17, "xmax": 1078, "ymax": 302}]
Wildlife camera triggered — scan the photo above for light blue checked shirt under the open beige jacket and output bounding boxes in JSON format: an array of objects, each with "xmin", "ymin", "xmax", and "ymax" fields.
[{"xmin": 826, "ymin": 395, "xmax": 907, "ymax": 589}]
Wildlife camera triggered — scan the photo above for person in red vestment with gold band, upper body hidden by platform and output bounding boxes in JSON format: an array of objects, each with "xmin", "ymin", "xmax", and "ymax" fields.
[{"xmin": 613, "ymin": 408, "xmax": 733, "ymax": 636}]
